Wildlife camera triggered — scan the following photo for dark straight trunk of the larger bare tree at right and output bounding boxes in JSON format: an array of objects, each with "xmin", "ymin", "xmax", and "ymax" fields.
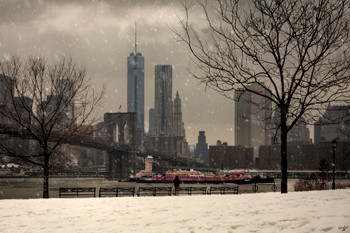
[{"xmin": 281, "ymin": 114, "xmax": 288, "ymax": 193}]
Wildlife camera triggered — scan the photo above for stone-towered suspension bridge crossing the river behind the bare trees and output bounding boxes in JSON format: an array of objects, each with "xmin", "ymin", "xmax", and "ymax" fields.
[{"xmin": 0, "ymin": 112, "xmax": 205, "ymax": 179}]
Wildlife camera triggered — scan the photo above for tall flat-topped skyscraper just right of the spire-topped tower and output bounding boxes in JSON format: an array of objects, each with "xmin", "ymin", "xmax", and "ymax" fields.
[{"xmin": 154, "ymin": 65, "xmax": 174, "ymax": 135}]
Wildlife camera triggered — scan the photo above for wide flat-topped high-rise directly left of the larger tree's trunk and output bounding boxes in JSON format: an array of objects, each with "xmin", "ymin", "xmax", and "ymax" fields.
[{"xmin": 235, "ymin": 84, "xmax": 272, "ymax": 157}]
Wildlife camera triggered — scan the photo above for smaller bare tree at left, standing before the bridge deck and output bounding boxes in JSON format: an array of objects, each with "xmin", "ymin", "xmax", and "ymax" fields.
[{"xmin": 0, "ymin": 57, "xmax": 104, "ymax": 198}]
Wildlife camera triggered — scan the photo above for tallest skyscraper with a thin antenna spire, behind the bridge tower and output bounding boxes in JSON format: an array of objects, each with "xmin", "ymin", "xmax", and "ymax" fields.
[{"xmin": 127, "ymin": 25, "xmax": 145, "ymax": 146}]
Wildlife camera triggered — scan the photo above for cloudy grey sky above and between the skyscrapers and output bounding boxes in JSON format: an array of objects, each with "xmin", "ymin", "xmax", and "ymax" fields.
[{"xmin": 0, "ymin": 0, "xmax": 234, "ymax": 145}]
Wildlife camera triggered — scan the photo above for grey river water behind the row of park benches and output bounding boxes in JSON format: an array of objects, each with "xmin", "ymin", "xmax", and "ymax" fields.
[{"xmin": 0, "ymin": 178, "xmax": 350, "ymax": 199}]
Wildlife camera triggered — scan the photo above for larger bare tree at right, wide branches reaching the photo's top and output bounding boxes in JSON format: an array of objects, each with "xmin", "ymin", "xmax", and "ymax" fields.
[{"xmin": 172, "ymin": 0, "xmax": 350, "ymax": 193}]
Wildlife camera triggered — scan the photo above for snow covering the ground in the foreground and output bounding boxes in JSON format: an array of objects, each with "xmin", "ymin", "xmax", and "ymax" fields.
[{"xmin": 0, "ymin": 189, "xmax": 350, "ymax": 233}]
